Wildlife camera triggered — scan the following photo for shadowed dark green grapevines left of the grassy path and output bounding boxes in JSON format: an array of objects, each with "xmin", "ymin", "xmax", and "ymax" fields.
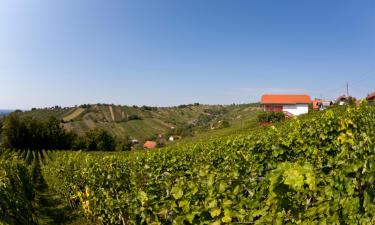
[{"xmin": 0, "ymin": 149, "xmax": 53, "ymax": 225}]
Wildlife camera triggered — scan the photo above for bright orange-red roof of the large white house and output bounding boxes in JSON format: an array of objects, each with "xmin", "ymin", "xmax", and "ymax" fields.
[{"xmin": 261, "ymin": 94, "xmax": 312, "ymax": 104}]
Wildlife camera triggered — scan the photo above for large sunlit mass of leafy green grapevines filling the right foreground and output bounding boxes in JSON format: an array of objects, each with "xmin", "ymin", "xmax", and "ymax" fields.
[{"xmin": 42, "ymin": 105, "xmax": 375, "ymax": 225}]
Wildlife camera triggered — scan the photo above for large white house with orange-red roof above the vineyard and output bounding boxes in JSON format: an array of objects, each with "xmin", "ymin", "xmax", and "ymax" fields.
[{"xmin": 261, "ymin": 94, "xmax": 312, "ymax": 116}]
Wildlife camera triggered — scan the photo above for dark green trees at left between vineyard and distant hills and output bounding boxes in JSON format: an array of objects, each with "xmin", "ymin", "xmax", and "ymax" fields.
[{"xmin": 0, "ymin": 113, "xmax": 131, "ymax": 151}]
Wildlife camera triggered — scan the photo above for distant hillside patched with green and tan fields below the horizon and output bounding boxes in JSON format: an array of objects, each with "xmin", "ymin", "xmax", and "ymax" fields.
[{"xmin": 21, "ymin": 104, "xmax": 259, "ymax": 141}]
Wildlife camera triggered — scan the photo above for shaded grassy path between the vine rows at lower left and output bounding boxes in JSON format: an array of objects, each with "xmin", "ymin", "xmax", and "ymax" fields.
[{"xmin": 34, "ymin": 166, "xmax": 93, "ymax": 225}]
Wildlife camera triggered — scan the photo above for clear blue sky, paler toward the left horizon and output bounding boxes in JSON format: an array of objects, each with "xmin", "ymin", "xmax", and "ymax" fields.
[{"xmin": 0, "ymin": 0, "xmax": 375, "ymax": 109}]
